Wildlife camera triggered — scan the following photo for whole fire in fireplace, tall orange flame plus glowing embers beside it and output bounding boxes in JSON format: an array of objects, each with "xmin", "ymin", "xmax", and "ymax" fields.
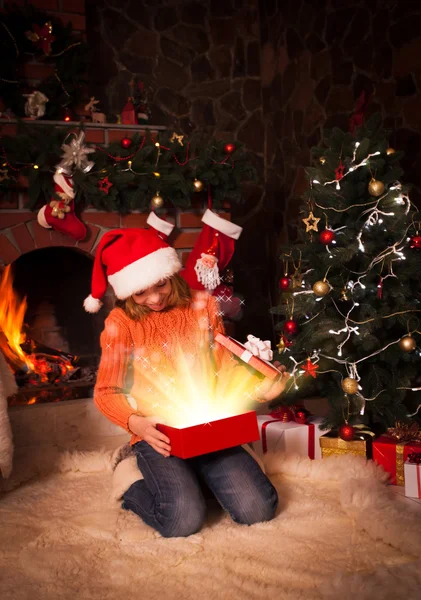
[{"xmin": 0, "ymin": 265, "xmax": 75, "ymax": 385}]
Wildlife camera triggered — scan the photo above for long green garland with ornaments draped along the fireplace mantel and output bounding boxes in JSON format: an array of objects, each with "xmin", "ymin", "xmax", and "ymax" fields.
[{"xmin": 0, "ymin": 122, "xmax": 256, "ymax": 214}]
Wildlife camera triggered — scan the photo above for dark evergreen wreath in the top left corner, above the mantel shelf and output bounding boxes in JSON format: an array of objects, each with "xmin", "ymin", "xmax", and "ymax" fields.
[{"xmin": 0, "ymin": 4, "xmax": 88, "ymax": 119}]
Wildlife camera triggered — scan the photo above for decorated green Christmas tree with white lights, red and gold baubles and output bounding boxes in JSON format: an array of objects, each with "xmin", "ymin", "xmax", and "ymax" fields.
[{"xmin": 272, "ymin": 115, "xmax": 421, "ymax": 430}]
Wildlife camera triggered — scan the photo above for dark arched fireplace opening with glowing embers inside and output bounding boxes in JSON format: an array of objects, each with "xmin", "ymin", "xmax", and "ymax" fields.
[{"xmin": 3, "ymin": 247, "xmax": 108, "ymax": 406}]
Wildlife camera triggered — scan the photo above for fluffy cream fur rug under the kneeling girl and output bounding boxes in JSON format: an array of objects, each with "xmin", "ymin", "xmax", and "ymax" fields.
[{"xmin": 0, "ymin": 451, "xmax": 421, "ymax": 600}]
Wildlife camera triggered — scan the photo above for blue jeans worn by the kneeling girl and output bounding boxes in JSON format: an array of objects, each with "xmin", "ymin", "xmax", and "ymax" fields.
[{"xmin": 122, "ymin": 441, "xmax": 278, "ymax": 537}]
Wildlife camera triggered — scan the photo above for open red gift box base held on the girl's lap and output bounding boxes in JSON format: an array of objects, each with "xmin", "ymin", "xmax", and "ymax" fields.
[{"xmin": 156, "ymin": 410, "xmax": 260, "ymax": 458}]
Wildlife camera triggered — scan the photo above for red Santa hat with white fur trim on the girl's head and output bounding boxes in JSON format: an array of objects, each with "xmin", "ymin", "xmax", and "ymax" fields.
[{"xmin": 84, "ymin": 223, "xmax": 181, "ymax": 313}]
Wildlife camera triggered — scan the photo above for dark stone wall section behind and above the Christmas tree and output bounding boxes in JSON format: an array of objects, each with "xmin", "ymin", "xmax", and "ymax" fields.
[{"xmin": 260, "ymin": 0, "xmax": 421, "ymax": 246}]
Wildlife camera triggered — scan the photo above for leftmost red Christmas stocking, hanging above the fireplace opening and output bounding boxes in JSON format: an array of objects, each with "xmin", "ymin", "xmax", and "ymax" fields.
[{"xmin": 37, "ymin": 170, "xmax": 86, "ymax": 241}]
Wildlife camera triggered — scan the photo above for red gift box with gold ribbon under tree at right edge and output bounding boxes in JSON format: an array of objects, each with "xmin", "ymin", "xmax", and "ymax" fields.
[{"xmin": 373, "ymin": 435, "xmax": 421, "ymax": 485}]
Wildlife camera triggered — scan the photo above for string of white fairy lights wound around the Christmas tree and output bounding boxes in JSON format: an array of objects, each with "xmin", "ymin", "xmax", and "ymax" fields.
[{"xmin": 278, "ymin": 142, "xmax": 421, "ymax": 423}]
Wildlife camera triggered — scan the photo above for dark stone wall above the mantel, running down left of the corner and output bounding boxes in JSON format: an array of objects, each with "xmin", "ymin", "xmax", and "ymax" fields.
[{"xmin": 86, "ymin": 0, "xmax": 271, "ymax": 337}]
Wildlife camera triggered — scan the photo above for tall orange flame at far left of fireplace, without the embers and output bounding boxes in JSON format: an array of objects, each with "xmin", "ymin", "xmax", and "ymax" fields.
[{"xmin": 0, "ymin": 265, "xmax": 34, "ymax": 371}]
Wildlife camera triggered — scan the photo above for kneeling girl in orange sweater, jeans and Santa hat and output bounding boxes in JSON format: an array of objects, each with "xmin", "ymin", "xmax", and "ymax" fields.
[{"xmin": 85, "ymin": 218, "xmax": 286, "ymax": 537}]
